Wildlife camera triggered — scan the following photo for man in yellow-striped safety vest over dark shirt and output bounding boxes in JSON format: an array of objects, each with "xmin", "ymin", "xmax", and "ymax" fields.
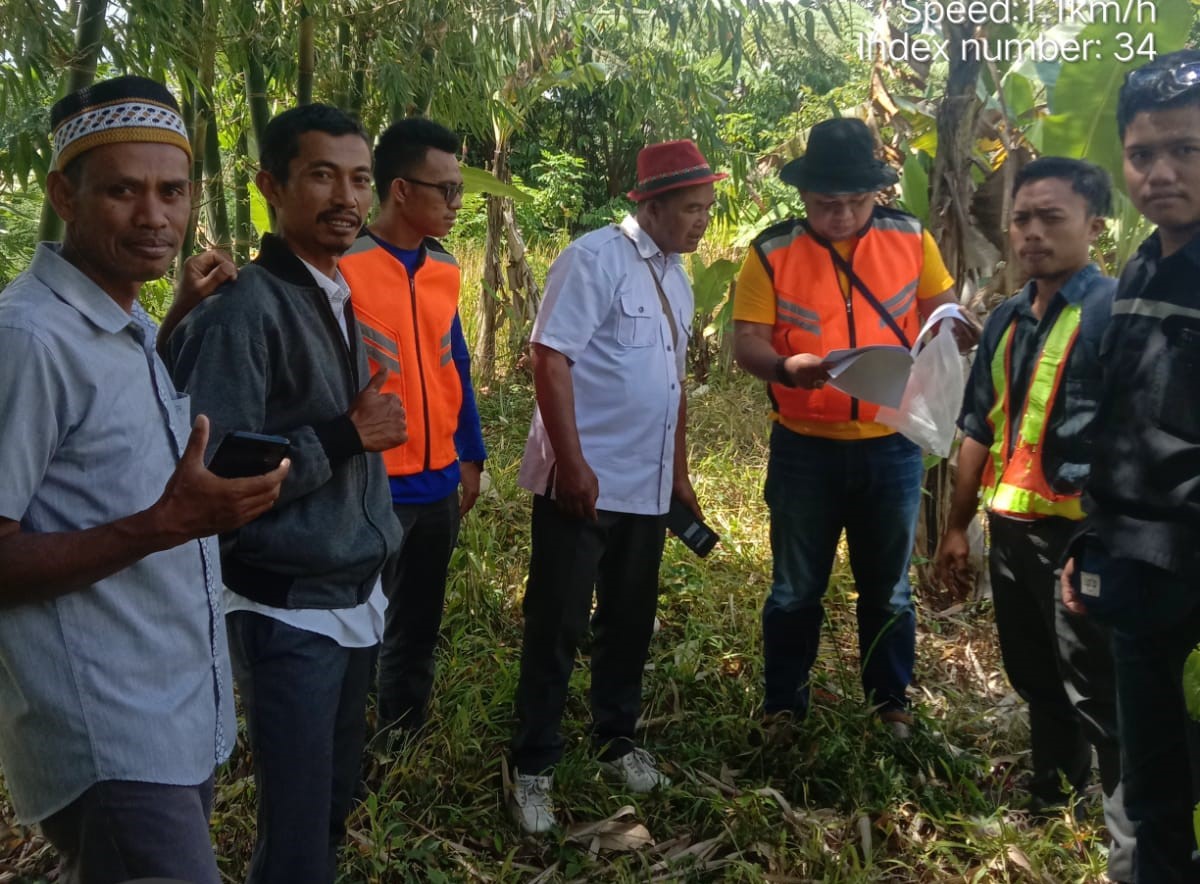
[{"xmin": 937, "ymin": 157, "xmax": 1135, "ymax": 882}]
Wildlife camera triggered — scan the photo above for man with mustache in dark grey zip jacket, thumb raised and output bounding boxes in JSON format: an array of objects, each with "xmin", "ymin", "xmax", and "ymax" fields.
[{"xmin": 167, "ymin": 104, "xmax": 406, "ymax": 884}]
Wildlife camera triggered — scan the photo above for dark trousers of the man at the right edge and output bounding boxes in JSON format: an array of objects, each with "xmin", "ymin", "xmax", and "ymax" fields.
[{"xmin": 1076, "ymin": 540, "xmax": 1200, "ymax": 884}]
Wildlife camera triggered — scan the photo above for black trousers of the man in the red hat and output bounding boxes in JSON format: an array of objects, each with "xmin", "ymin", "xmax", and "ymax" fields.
[{"xmin": 512, "ymin": 495, "xmax": 666, "ymax": 774}]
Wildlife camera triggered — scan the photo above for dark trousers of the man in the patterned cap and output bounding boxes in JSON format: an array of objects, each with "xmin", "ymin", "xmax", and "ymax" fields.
[{"xmin": 42, "ymin": 777, "xmax": 221, "ymax": 884}]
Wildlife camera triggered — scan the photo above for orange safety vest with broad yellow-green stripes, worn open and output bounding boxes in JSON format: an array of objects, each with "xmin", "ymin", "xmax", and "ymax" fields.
[{"xmin": 983, "ymin": 303, "xmax": 1084, "ymax": 521}]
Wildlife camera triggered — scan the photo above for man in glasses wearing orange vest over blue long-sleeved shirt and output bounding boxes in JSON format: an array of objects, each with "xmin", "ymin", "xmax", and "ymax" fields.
[{"xmin": 341, "ymin": 118, "xmax": 486, "ymax": 734}]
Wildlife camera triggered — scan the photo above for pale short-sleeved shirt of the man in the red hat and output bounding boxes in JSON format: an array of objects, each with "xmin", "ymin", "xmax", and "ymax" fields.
[{"xmin": 517, "ymin": 216, "xmax": 695, "ymax": 516}]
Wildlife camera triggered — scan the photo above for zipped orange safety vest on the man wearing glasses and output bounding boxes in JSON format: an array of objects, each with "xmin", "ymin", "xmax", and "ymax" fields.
[{"xmin": 337, "ymin": 234, "xmax": 462, "ymax": 476}]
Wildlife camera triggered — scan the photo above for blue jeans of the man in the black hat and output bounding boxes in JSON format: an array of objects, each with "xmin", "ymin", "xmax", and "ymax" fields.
[{"xmin": 762, "ymin": 425, "xmax": 924, "ymax": 717}]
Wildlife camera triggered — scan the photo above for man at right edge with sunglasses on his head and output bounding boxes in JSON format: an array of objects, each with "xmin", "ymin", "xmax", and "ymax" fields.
[{"xmin": 1062, "ymin": 50, "xmax": 1200, "ymax": 882}]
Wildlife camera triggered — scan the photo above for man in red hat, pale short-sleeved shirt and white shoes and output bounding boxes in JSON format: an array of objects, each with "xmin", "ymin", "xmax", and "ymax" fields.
[{"xmin": 511, "ymin": 140, "xmax": 726, "ymax": 834}]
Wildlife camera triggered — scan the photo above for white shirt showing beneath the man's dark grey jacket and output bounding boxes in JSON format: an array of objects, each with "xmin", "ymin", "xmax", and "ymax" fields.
[{"xmin": 224, "ymin": 255, "xmax": 388, "ymax": 648}]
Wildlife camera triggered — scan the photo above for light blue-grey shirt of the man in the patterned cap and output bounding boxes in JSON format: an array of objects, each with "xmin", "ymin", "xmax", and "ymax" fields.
[{"xmin": 0, "ymin": 243, "xmax": 236, "ymax": 822}]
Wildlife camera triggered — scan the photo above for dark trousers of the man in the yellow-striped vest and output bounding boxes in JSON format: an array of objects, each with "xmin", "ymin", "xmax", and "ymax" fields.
[{"xmin": 988, "ymin": 515, "xmax": 1138, "ymax": 882}]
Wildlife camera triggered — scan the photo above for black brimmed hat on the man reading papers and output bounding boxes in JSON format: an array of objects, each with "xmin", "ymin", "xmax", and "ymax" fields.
[{"xmin": 779, "ymin": 118, "xmax": 900, "ymax": 193}]
